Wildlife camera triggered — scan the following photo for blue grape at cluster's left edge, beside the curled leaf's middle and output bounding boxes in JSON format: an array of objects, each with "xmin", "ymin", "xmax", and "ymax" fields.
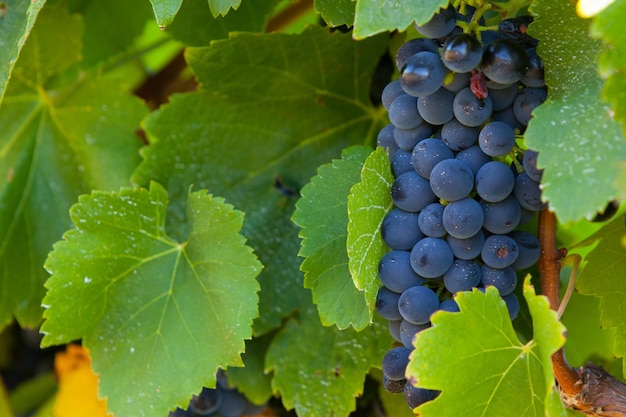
[{"xmin": 380, "ymin": 208, "xmax": 424, "ymax": 250}]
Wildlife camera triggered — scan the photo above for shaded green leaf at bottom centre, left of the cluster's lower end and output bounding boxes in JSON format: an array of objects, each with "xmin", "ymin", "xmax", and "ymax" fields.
[{"xmin": 266, "ymin": 306, "xmax": 391, "ymax": 417}]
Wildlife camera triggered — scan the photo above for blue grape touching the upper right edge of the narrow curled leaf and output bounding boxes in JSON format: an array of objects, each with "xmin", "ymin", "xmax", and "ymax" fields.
[{"xmin": 391, "ymin": 171, "xmax": 437, "ymax": 212}]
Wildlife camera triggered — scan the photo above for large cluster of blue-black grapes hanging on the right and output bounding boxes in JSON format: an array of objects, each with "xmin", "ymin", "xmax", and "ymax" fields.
[{"xmin": 376, "ymin": 6, "xmax": 546, "ymax": 408}]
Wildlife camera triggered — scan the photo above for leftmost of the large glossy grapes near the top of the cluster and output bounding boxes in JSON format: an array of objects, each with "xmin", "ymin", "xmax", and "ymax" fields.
[{"xmin": 400, "ymin": 51, "xmax": 445, "ymax": 97}]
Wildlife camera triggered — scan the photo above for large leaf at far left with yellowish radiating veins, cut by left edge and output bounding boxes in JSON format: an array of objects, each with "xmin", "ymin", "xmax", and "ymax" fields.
[{"xmin": 0, "ymin": 2, "xmax": 146, "ymax": 328}]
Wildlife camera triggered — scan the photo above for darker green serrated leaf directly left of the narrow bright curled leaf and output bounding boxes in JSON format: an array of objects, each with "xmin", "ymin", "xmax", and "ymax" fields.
[{"xmin": 291, "ymin": 146, "xmax": 372, "ymax": 330}]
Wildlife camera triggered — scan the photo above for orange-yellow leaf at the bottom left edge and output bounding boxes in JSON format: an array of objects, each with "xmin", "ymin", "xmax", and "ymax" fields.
[{"xmin": 53, "ymin": 345, "xmax": 113, "ymax": 417}]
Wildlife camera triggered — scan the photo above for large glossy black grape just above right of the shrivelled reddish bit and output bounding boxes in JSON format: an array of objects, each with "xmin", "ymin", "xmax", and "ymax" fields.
[{"xmin": 481, "ymin": 39, "xmax": 529, "ymax": 85}]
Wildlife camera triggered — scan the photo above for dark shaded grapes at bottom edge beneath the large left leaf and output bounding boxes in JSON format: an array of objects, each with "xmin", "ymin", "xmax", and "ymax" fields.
[{"xmin": 169, "ymin": 371, "xmax": 266, "ymax": 417}]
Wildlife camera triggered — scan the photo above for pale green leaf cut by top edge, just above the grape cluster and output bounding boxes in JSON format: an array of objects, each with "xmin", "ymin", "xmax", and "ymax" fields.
[{"xmin": 354, "ymin": 0, "xmax": 448, "ymax": 39}]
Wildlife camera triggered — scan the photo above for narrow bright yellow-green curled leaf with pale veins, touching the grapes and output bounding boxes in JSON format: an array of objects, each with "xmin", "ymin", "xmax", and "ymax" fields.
[{"xmin": 347, "ymin": 147, "xmax": 393, "ymax": 312}]
